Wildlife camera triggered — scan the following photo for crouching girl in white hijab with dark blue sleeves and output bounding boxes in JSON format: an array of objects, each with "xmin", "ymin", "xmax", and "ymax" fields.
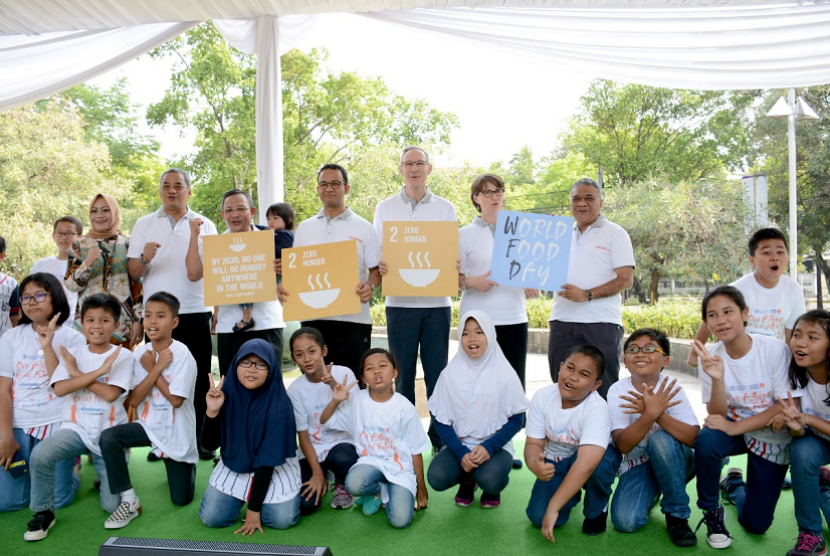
[{"xmin": 427, "ymin": 311, "xmax": 530, "ymax": 508}]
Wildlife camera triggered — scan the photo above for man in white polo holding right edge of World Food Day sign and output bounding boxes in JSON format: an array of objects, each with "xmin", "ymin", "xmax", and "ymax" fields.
[{"xmin": 548, "ymin": 178, "xmax": 635, "ymax": 398}]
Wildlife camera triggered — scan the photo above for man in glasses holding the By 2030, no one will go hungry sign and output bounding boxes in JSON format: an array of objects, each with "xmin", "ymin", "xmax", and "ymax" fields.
[{"xmin": 187, "ymin": 189, "xmax": 285, "ymax": 376}]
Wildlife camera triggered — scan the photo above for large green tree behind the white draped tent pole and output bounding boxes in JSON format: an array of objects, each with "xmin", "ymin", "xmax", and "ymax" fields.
[{"xmin": 148, "ymin": 22, "xmax": 458, "ymax": 225}]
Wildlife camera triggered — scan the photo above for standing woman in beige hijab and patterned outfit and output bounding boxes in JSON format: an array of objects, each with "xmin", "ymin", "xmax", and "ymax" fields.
[{"xmin": 64, "ymin": 193, "xmax": 144, "ymax": 349}]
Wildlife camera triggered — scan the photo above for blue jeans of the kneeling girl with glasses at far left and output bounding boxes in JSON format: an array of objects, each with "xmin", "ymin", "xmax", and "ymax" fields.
[{"xmin": 0, "ymin": 429, "xmax": 81, "ymax": 513}]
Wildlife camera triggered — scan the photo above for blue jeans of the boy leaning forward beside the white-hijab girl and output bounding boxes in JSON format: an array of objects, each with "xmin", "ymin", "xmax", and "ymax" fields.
[{"xmin": 525, "ymin": 450, "xmax": 620, "ymax": 527}]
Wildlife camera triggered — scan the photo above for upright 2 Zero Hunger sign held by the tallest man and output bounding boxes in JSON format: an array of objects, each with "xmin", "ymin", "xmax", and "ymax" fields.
[{"xmin": 383, "ymin": 221, "xmax": 458, "ymax": 297}]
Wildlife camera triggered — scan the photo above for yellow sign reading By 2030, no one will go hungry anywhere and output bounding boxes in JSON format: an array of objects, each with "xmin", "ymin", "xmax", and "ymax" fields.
[{"xmin": 202, "ymin": 230, "xmax": 277, "ymax": 305}]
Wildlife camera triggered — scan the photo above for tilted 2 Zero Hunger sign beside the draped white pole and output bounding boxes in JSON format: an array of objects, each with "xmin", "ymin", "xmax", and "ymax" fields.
[{"xmin": 282, "ymin": 240, "xmax": 360, "ymax": 321}]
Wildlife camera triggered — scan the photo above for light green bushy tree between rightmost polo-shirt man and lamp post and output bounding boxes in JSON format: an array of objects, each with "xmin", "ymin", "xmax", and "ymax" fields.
[{"xmin": 603, "ymin": 181, "xmax": 746, "ymax": 304}]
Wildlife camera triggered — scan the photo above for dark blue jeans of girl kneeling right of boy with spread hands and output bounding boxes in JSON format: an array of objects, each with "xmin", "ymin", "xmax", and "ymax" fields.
[{"xmin": 695, "ymin": 428, "xmax": 788, "ymax": 535}]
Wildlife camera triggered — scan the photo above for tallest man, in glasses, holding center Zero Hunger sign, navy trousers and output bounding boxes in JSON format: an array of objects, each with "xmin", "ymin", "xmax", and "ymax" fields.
[{"xmin": 374, "ymin": 147, "xmax": 457, "ymax": 451}]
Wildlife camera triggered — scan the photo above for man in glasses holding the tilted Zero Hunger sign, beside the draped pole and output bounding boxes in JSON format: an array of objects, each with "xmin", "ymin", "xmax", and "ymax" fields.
[{"xmin": 294, "ymin": 164, "xmax": 380, "ymax": 376}]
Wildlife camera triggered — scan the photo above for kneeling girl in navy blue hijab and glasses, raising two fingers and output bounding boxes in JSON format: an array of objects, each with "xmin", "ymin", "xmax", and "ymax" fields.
[{"xmin": 199, "ymin": 339, "xmax": 301, "ymax": 535}]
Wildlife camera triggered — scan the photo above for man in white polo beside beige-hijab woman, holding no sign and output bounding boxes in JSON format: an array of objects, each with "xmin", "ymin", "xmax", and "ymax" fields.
[{"xmin": 127, "ymin": 168, "xmax": 216, "ymax": 459}]
